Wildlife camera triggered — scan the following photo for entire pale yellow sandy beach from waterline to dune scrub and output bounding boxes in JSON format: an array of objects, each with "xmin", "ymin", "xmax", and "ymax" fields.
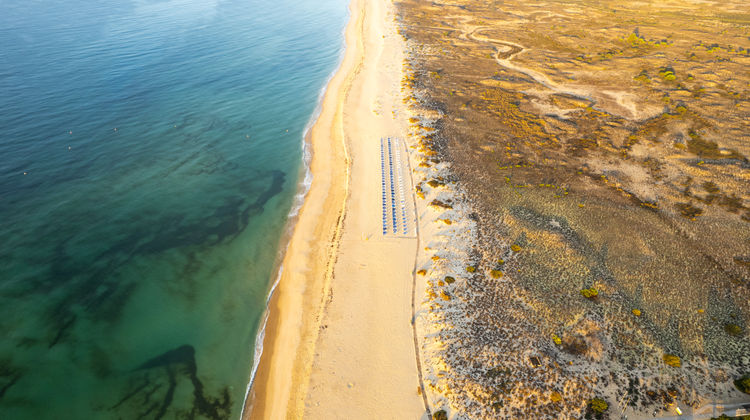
[{"xmin": 245, "ymin": 0, "xmax": 425, "ymax": 419}]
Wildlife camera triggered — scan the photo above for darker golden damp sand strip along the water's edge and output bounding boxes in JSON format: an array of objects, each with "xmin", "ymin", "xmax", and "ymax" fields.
[{"xmin": 242, "ymin": 0, "xmax": 362, "ymax": 419}]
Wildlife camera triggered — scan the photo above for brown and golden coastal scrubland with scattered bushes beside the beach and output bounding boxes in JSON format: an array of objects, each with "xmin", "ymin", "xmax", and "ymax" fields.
[{"xmin": 396, "ymin": 0, "xmax": 750, "ymax": 418}]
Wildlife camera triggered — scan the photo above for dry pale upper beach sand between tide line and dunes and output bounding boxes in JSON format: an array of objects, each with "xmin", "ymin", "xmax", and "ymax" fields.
[{"xmin": 304, "ymin": 1, "xmax": 425, "ymax": 419}]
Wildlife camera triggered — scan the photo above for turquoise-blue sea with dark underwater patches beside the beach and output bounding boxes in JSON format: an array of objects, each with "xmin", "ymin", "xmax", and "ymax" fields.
[{"xmin": 0, "ymin": 0, "xmax": 348, "ymax": 419}]
